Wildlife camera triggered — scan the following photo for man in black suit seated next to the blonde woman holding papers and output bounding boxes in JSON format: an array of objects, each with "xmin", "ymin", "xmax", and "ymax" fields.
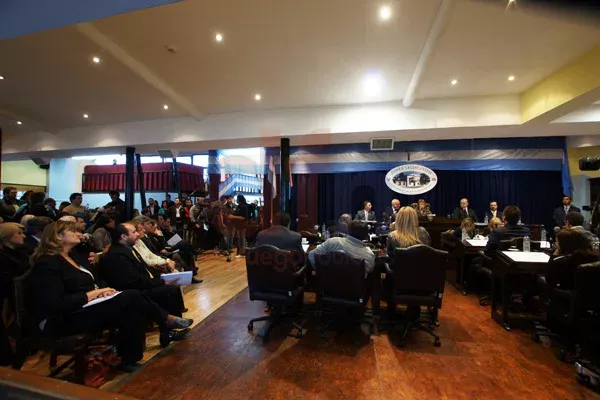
[{"xmin": 100, "ymin": 223, "xmax": 184, "ymax": 317}]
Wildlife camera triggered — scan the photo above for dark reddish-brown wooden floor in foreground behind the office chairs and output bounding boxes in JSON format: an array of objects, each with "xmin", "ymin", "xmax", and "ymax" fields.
[{"xmin": 115, "ymin": 276, "xmax": 600, "ymax": 400}]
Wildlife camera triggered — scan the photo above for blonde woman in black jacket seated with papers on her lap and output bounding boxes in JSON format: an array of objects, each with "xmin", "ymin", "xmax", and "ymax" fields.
[{"xmin": 30, "ymin": 221, "xmax": 191, "ymax": 366}]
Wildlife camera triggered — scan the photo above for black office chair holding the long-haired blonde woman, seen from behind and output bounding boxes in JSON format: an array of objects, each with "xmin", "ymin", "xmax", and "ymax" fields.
[{"xmin": 386, "ymin": 244, "xmax": 448, "ymax": 347}]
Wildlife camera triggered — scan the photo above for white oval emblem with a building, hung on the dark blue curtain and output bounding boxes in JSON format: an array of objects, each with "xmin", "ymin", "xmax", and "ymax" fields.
[{"xmin": 385, "ymin": 164, "xmax": 437, "ymax": 196}]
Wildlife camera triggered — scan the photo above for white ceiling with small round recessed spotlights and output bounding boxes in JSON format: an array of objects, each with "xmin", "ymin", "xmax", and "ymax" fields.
[{"xmin": 0, "ymin": 0, "xmax": 600, "ymax": 149}]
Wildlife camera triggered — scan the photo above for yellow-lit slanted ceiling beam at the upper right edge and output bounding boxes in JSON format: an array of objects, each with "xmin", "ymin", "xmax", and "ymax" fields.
[{"xmin": 520, "ymin": 45, "xmax": 600, "ymax": 123}]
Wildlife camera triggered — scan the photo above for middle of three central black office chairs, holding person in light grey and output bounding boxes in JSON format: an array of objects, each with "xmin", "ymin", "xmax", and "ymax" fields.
[{"xmin": 315, "ymin": 250, "xmax": 370, "ymax": 337}]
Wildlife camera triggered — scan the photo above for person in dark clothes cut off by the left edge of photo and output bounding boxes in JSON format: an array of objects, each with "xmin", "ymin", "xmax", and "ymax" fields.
[{"xmin": 0, "ymin": 222, "xmax": 29, "ymax": 365}]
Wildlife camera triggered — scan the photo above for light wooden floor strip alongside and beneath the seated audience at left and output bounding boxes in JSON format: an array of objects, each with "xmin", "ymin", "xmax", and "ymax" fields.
[{"xmin": 22, "ymin": 253, "xmax": 247, "ymax": 390}]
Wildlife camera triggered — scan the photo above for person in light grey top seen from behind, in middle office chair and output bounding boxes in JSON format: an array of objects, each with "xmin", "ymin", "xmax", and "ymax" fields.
[{"xmin": 308, "ymin": 221, "xmax": 375, "ymax": 278}]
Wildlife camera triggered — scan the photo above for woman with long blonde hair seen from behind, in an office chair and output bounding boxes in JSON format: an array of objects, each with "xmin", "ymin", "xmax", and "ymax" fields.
[{"xmin": 387, "ymin": 207, "xmax": 431, "ymax": 256}]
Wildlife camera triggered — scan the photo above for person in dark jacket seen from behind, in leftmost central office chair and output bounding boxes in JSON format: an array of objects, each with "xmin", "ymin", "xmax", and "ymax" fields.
[{"xmin": 256, "ymin": 213, "xmax": 305, "ymax": 265}]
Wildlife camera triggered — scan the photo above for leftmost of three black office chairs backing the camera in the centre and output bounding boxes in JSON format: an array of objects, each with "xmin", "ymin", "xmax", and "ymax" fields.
[{"xmin": 246, "ymin": 245, "xmax": 306, "ymax": 341}]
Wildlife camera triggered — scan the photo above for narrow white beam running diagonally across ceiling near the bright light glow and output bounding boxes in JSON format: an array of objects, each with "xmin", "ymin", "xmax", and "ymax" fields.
[{"xmin": 402, "ymin": 0, "xmax": 454, "ymax": 107}]
